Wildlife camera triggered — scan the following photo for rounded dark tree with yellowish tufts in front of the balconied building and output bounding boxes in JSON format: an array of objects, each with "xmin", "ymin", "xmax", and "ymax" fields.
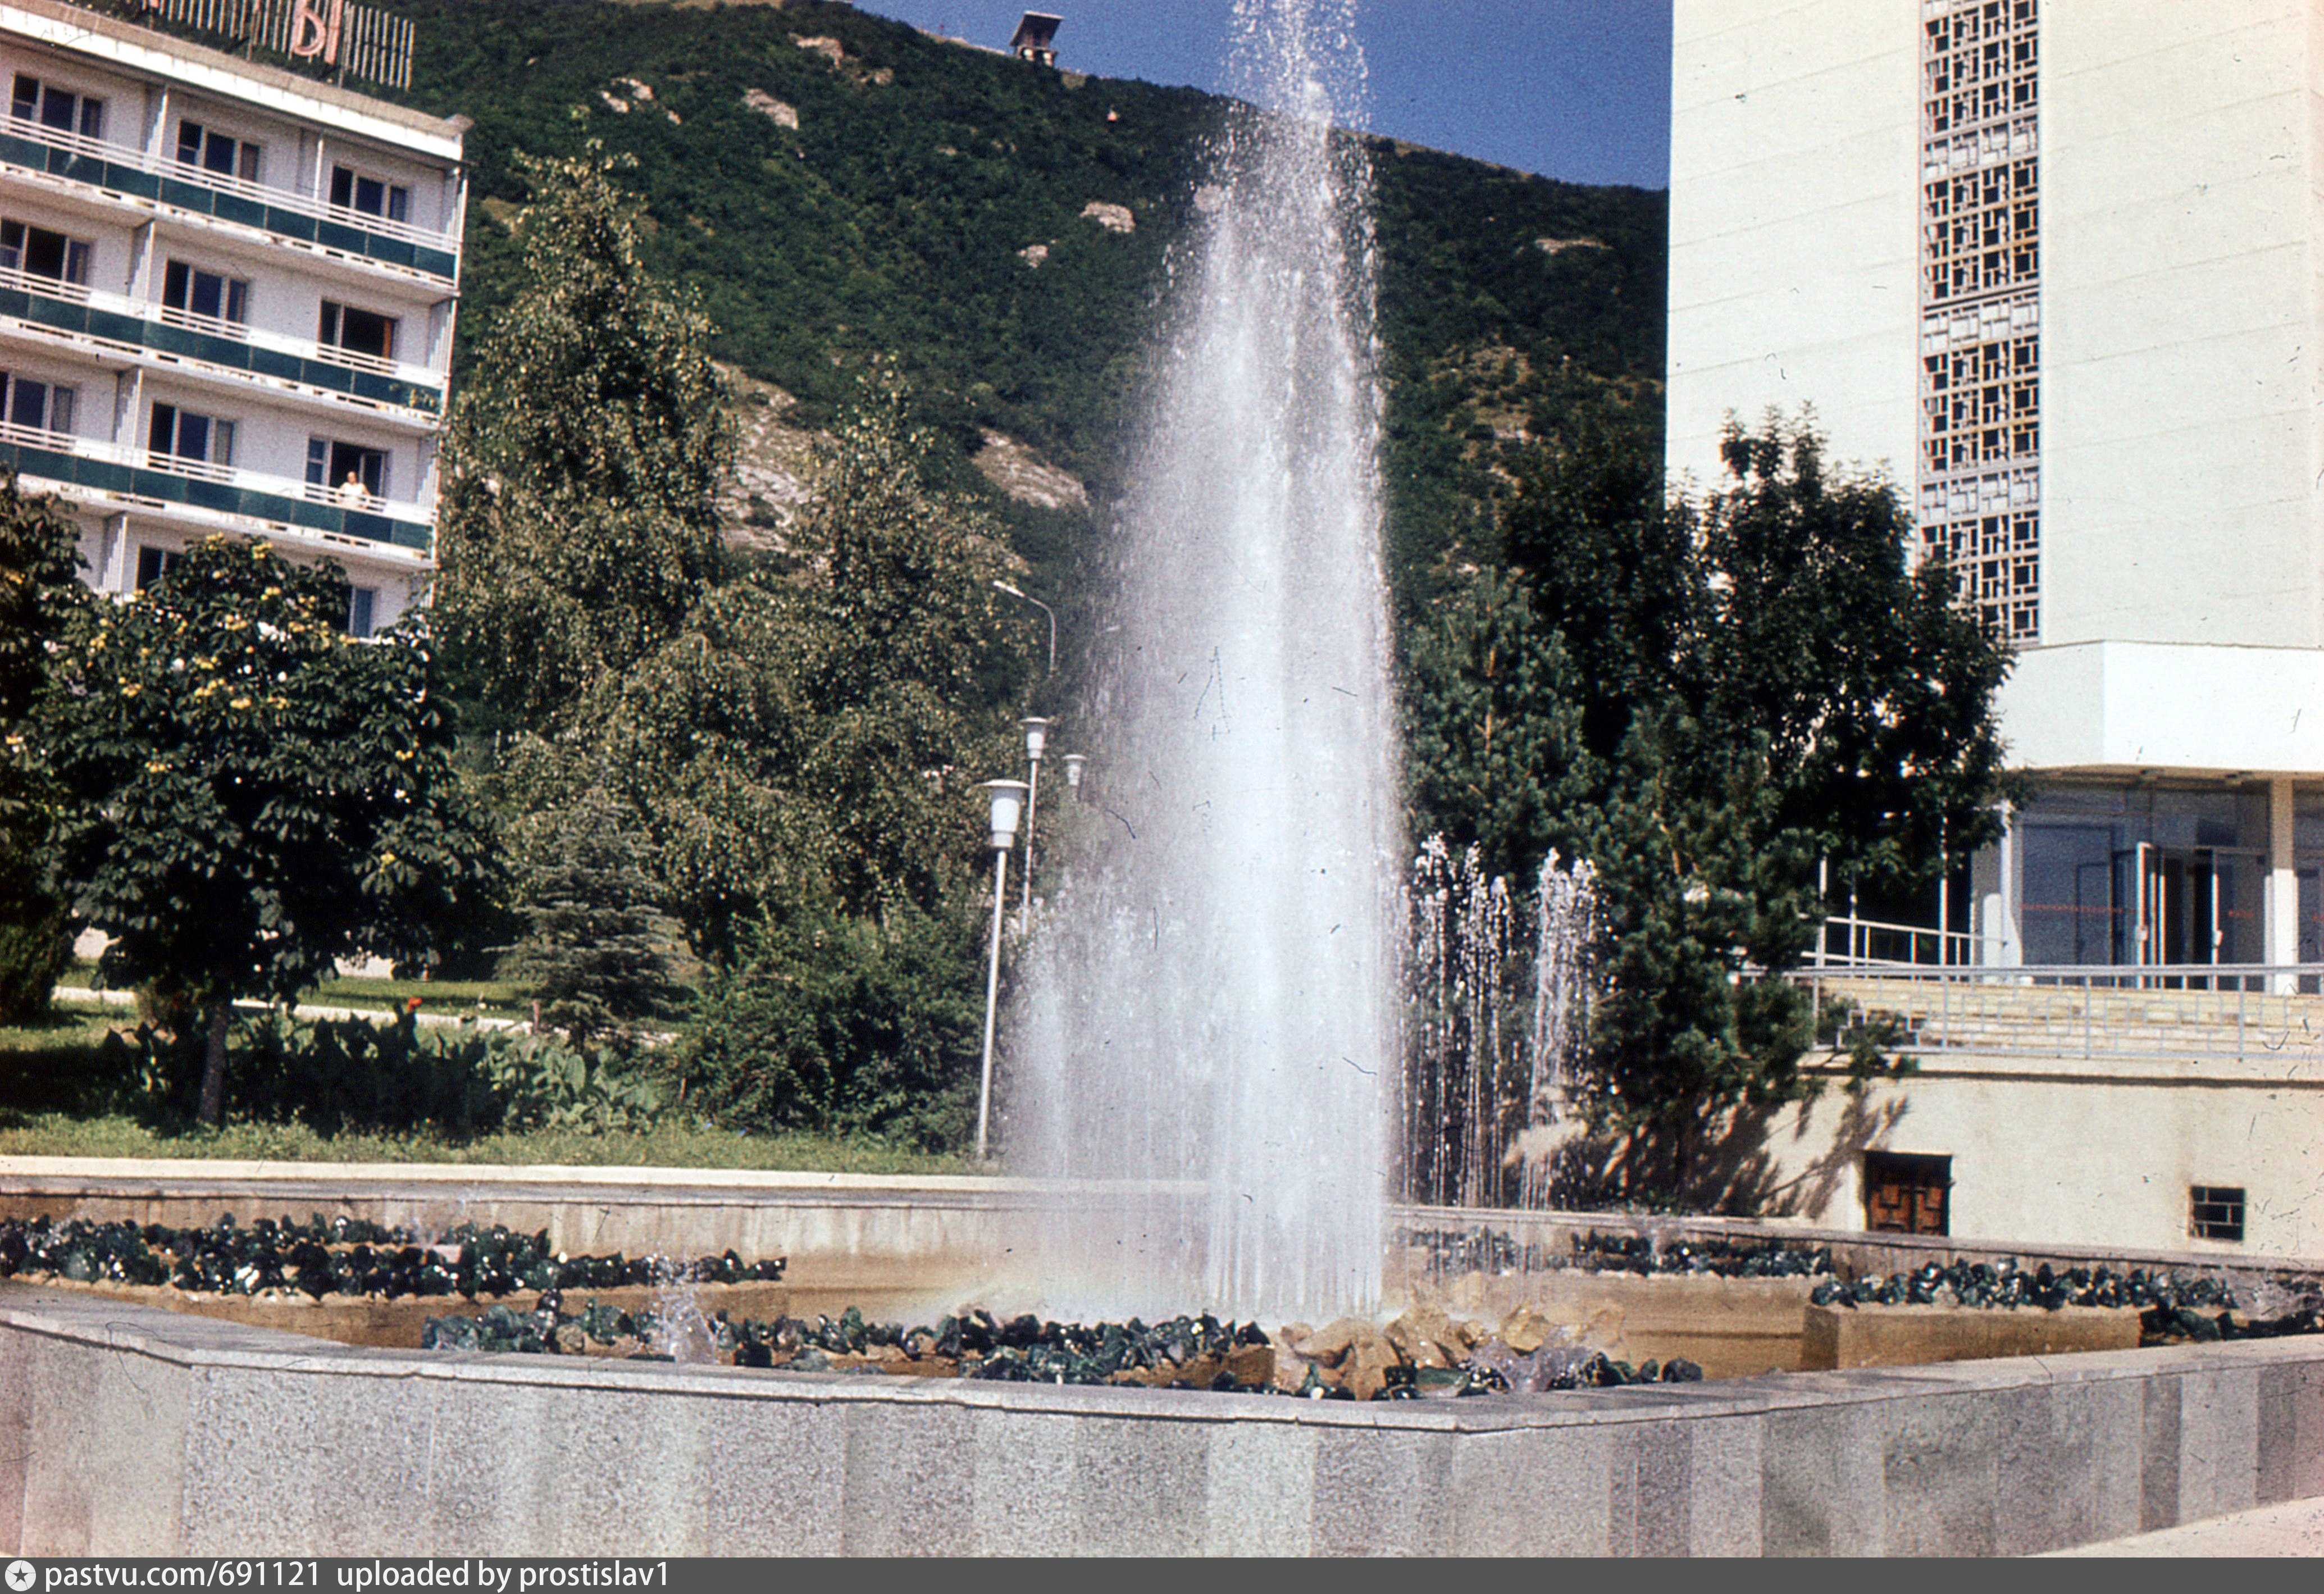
[{"xmin": 37, "ymin": 537, "xmax": 486, "ymax": 1122}]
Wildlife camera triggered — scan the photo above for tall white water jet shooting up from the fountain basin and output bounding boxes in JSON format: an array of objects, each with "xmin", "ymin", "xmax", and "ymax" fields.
[{"xmin": 1011, "ymin": 0, "xmax": 1403, "ymax": 1315}]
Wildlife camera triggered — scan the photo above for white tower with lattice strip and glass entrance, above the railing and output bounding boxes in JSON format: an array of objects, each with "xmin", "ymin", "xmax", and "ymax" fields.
[{"xmin": 1669, "ymin": 0, "xmax": 2324, "ymax": 980}]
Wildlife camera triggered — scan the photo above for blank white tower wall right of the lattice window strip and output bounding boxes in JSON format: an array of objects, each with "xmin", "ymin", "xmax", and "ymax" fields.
[{"xmin": 2040, "ymin": 0, "xmax": 2324, "ymax": 648}]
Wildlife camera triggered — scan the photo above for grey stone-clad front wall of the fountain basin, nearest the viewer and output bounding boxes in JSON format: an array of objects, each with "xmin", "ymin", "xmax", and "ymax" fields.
[{"xmin": 0, "ymin": 1285, "xmax": 2324, "ymax": 1555}]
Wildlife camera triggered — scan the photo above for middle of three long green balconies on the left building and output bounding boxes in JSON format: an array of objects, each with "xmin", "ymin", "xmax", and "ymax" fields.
[{"xmin": 0, "ymin": 270, "xmax": 444, "ymax": 425}]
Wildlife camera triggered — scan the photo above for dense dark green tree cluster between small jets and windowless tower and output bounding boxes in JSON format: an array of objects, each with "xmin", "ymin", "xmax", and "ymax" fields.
[{"xmin": 1413, "ymin": 421, "xmax": 2013, "ymax": 1199}]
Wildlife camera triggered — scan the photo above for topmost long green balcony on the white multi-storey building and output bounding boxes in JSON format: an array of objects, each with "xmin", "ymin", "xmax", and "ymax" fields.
[{"xmin": 0, "ymin": 116, "xmax": 460, "ymax": 288}]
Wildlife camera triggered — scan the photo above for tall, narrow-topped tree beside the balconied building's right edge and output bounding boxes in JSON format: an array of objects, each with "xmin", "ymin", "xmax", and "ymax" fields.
[{"xmin": 437, "ymin": 147, "xmax": 735, "ymax": 727}]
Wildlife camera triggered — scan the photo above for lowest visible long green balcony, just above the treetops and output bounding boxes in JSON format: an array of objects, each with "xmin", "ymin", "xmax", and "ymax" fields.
[{"xmin": 0, "ymin": 423, "xmax": 435, "ymax": 555}]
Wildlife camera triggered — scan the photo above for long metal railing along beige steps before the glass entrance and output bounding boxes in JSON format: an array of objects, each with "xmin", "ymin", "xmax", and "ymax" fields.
[{"xmin": 1785, "ymin": 962, "xmax": 2324, "ymax": 1081}]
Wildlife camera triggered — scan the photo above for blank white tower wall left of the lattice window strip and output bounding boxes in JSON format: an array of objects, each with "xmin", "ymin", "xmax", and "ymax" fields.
[{"xmin": 1669, "ymin": 0, "xmax": 1920, "ymax": 490}]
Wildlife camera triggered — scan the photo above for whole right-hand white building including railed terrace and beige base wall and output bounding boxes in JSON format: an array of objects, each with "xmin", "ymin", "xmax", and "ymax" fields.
[{"xmin": 1666, "ymin": 0, "xmax": 2324, "ymax": 1257}]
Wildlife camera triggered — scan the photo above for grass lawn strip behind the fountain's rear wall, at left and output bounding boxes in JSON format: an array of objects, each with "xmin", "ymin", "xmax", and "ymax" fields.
[{"xmin": 0, "ymin": 1013, "xmax": 978, "ymax": 1173}]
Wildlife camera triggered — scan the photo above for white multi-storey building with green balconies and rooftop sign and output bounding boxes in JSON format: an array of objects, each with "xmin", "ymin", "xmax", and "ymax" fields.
[{"xmin": 0, "ymin": 0, "xmax": 467, "ymax": 634}]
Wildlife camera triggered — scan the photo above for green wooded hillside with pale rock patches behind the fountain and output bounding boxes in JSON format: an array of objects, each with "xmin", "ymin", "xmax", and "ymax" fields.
[{"xmin": 376, "ymin": 0, "xmax": 1664, "ymax": 613}]
